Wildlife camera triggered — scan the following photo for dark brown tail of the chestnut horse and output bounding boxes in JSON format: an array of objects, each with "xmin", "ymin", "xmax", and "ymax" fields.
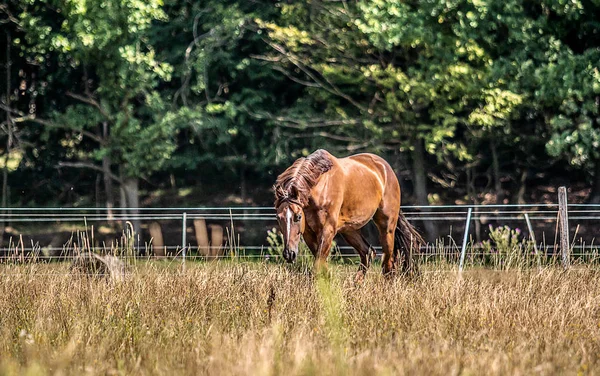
[{"xmin": 394, "ymin": 212, "xmax": 425, "ymax": 275}]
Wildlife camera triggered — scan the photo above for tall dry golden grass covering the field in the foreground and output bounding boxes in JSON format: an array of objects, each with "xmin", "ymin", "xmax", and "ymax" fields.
[{"xmin": 0, "ymin": 263, "xmax": 600, "ymax": 375}]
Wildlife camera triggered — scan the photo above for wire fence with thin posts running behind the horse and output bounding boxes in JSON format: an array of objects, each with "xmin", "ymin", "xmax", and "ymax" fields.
[{"xmin": 0, "ymin": 200, "xmax": 600, "ymax": 264}]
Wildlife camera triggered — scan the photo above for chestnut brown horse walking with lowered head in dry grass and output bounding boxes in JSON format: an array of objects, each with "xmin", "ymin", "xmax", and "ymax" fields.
[{"xmin": 273, "ymin": 150, "xmax": 423, "ymax": 279}]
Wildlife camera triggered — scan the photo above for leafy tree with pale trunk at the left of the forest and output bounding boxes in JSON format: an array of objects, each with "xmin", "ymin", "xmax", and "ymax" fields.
[{"xmin": 9, "ymin": 0, "xmax": 175, "ymax": 230}]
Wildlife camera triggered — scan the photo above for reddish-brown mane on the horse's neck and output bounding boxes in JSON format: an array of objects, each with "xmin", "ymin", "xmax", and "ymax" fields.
[{"xmin": 273, "ymin": 150, "xmax": 333, "ymax": 207}]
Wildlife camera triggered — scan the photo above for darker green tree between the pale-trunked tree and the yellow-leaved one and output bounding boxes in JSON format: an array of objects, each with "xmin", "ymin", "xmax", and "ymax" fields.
[{"xmin": 153, "ymin": 1, "xmax": 324, "ymax": 201}]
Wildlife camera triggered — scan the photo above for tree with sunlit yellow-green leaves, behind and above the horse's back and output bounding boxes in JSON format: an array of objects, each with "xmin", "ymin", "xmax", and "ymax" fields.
[{"xmin": 258, "ymin": 1, "xmax": 510, "ymax": 238}]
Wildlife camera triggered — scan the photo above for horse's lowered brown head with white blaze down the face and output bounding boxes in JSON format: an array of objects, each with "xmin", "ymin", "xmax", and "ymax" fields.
[{"xmin": 277, "ymin": 200, "xmax": 304, "ymax": 262}]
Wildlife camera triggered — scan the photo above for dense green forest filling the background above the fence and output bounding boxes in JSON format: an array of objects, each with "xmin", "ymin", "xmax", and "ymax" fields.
[{"xmin": 0, "ymin": 0, "xmax": 600, "ymax": 214}]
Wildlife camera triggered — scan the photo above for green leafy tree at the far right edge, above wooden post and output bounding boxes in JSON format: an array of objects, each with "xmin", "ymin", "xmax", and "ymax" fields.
[{"xmin": 482, "ymin": 1, "xmax": 600, "ymax": 201}]
